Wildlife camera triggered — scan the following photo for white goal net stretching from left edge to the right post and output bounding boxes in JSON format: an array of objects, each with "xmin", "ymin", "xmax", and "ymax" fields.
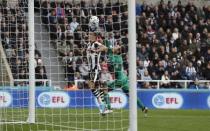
[{"xmin": 0, "ymin": 0, "xmax": 129, "ymax": 131}]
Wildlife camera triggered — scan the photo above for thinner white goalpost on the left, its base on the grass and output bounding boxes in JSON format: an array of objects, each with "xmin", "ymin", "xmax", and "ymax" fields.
[{"xmin": 27, "ymin": 0, "xmax": 35, "ymax": 123}]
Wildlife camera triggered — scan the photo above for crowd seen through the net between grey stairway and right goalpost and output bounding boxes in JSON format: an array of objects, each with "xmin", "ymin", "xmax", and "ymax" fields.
[{"xmin": 41, "ymin": 0, "xmax": 128, "ymax": 88}]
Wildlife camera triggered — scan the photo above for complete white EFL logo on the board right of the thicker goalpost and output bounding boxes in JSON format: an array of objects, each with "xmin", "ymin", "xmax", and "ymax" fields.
[{"xmin": 152, "ymin": 93, "xmax": 183, "ymax": 109}]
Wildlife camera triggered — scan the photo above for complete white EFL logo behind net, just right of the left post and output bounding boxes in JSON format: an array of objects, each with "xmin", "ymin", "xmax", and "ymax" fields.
[{"xmin": 38, "ymin": 92, "xmax": 70, "ymax": 108}]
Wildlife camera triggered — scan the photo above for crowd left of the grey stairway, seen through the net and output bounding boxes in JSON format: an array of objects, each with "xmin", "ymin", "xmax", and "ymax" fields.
[{"xmin": 0, "ymin": 3, "xmax": 47, "ymax": 86}]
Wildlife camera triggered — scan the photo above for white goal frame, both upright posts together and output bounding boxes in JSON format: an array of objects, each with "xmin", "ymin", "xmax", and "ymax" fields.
[{"xmin": 1, "ymin": 0, "xmax": 138, "ymax": 131}]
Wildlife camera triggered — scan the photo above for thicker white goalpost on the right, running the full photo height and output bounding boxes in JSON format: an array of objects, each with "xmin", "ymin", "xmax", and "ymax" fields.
[{"xmin": 128, "ymin": 0, "xmax": 137, "ymax": 131}]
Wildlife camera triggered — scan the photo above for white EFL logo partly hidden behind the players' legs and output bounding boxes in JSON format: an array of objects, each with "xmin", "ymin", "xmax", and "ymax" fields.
[{"xmin": 95, "ymin": 92, "xmax": 128, "ymax": 109}]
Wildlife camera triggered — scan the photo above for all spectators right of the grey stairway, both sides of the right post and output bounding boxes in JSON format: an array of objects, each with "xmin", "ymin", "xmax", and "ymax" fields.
[{"xmin": 41, "ymin": 0, "xmax": 210, "ymax": 88}]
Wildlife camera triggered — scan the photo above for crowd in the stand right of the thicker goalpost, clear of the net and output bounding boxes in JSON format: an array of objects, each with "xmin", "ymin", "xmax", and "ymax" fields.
[{"xmin": 137, "ymin": 0, "xmax": 210, "ymax": 88}]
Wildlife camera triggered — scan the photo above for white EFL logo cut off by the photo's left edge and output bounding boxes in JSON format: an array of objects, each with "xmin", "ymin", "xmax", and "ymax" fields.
[{"xmin": 0, "ymin": 92, "xmax": 12, "ymax": 108}]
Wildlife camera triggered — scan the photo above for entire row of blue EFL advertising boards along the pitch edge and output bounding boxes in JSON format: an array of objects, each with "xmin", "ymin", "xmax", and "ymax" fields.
[{"xmin": 0, "ymin": 88, "xmax": 210, "ymax": 109}]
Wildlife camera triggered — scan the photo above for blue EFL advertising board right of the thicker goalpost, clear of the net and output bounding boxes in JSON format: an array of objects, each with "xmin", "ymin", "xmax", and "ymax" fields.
[{"xmin": 138, "ymin": 90, "xmax": 210, "ymax": 109}]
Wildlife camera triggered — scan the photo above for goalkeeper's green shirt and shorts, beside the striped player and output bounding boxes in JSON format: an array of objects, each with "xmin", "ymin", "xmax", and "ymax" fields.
[{"xmin": 105, "ymin": 41, "xmax": 128, "ymax": 90}]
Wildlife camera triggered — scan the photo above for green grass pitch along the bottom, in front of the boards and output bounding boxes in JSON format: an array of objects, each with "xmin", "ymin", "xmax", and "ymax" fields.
[{"xmin": 0, "ymin": 109, "xmax": 210, "ymax": 131}]
